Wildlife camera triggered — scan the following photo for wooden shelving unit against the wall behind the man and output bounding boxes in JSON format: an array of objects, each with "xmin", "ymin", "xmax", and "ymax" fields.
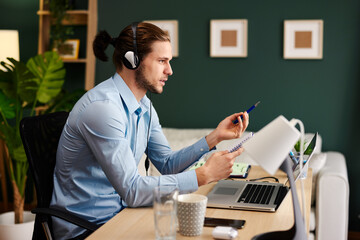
[{"xmin": 37, "ymin": 0, "xmax": 98, "ymax": 90}]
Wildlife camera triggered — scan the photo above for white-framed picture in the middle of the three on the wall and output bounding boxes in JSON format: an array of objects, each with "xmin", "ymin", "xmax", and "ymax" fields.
[{"xmin": 210, "ymin": 19, "xmax": 248, "ymax": 57}]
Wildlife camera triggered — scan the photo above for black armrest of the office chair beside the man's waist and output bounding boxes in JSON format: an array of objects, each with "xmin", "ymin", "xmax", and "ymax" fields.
[{"xmin": 31, "ymin": 208, "xmax": 101, "ymax": 232}]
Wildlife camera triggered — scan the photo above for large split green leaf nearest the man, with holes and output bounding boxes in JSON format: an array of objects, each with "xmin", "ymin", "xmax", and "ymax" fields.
[{"xmin": 26, "ymin": 52, "xmax": 65, "ymax": 103}]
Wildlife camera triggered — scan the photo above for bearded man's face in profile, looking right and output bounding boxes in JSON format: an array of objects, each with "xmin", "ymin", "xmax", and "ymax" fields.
[{"xmin": 135, "ymin": 41, "xmax": 173, "ymax": 94}]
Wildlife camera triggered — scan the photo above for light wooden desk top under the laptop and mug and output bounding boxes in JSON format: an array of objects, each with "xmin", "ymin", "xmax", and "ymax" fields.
[{"xmin": 87, "ymin": 166, "xmax": 312, "ymax": 240}]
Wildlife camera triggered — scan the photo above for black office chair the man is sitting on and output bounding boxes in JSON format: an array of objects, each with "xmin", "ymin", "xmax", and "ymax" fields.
[{"xmin": 20, "ymin": 112, "xmax": 100, "ymax": 240}]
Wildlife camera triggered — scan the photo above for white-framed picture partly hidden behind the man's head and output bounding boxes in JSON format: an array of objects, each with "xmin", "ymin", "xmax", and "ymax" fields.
[{"xmin": 145, "ymin": 20, "xmax": 179, "ymax": 57}]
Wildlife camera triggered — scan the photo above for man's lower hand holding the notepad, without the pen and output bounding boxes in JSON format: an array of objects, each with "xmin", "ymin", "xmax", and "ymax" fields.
[{"xmin": 195, "ymin": 148, "xmax": 244, "ymax": 186}]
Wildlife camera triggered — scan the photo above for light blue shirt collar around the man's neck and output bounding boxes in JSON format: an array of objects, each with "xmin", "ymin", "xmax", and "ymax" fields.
[{"xmin": 113, "ymin": 73, "xmax": 150, "ymax": 115}]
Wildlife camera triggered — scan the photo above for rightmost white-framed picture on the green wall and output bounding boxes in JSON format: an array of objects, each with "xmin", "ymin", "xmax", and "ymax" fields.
[{"xmin": 284, "ymin": 20, "xmax": 324, "ymax": 59}]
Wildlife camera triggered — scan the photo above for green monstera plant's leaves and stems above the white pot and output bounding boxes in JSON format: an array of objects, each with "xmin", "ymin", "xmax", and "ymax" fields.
[{"xmin": 0, "ymin": 51, "xmax": 65, "ymax": 227}]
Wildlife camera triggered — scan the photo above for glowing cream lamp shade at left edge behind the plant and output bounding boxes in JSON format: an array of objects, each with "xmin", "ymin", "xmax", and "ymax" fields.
[{"xmin": 0, "ymin": 30, "xmax": 20, "ymax": 70}]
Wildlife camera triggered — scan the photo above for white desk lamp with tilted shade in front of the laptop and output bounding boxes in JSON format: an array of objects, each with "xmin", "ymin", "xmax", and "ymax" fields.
[{"xmin": 243, "ymin": 116, "xmax": 307, "ymax": 240}]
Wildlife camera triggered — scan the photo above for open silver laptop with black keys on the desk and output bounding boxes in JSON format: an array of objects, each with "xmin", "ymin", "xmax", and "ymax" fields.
[{"xmin": 207, "ymin": 133, "xmax": 318, "ymax": 212}]
